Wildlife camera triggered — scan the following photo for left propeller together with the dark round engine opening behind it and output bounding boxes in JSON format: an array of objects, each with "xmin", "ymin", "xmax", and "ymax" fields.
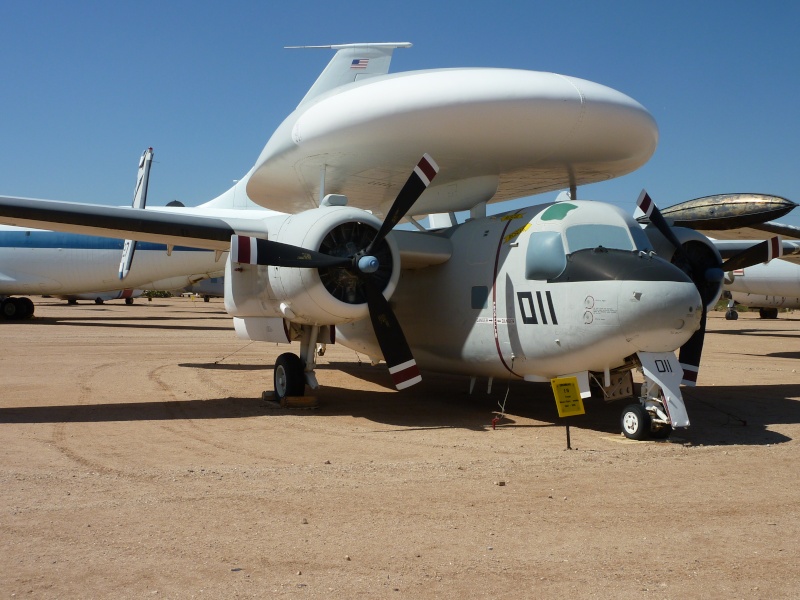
[{"xmin": 231, "ymin": 154, "xmax": 439, "ymax": 390}]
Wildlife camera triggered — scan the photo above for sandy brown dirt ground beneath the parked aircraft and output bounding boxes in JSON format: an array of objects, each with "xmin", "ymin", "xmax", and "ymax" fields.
[{"xmin": 0, "ymin": 298, "xmax": 800, "ymax": 599}]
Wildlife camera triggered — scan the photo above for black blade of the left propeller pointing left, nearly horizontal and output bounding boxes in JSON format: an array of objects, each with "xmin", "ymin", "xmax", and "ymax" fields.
[{"xmin": 231, "ymin": 235, "xmax": 352, "ymax": 269}]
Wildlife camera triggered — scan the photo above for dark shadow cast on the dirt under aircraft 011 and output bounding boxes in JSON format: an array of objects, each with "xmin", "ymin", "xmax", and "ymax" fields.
[{"xmin": 6, "ymin": 356, "xmax": 800, "ymax": 445}]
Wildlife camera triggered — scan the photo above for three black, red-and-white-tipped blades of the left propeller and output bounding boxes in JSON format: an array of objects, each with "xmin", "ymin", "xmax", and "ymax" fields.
[{"xmin": 231, "ymin": 154, "xmax": 439, "ymax": 390}]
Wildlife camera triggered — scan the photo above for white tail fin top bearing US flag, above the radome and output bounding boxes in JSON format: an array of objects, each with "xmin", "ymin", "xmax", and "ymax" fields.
[{"xmin": 287, "ymin": 42, "xmax": 411, "ymax": 106}]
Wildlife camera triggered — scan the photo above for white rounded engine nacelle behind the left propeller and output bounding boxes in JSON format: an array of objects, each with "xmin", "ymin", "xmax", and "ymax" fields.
[{"xmin": 225, "ymin": 206, "xmax": 400, "ymax": 325}]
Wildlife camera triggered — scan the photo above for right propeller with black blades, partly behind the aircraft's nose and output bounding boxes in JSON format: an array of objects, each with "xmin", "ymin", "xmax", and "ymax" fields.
[{"xmin": 636, "ymin": 190, "xmax": 783, "ymax": 386}]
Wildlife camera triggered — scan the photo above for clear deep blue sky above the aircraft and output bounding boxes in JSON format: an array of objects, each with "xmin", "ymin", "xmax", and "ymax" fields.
[{"xmin": 0, "ymin": 0, "xmax": 800, "ymax": 225}]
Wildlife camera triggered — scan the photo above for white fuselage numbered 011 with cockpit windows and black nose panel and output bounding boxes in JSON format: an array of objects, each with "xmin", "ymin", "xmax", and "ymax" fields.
[{"xmin": 337, "ymin": 202, "xmax": 701, "ymax": 379}]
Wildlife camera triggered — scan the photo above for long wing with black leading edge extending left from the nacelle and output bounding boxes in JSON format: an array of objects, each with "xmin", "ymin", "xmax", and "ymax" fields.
[{"xmin": 0, "ymin": 196, "xmax": 252, "ymax": 251}]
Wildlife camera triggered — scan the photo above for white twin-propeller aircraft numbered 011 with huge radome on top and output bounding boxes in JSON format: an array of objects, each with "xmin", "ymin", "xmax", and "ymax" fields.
[{"xmin": 0, "ymin": 43, "xmax": 790, "ymax": 439}]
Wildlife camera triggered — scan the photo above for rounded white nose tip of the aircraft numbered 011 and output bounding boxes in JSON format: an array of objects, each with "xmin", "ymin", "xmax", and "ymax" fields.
[{"xmin": 618, "ymin": 263, "xmax": 702, "ymax": 352}]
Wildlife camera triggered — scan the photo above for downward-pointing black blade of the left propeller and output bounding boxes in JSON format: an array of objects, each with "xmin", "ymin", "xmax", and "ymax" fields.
[{"xmin": 361, "ymin": 276, "xmax": 422, "ymax": 390}]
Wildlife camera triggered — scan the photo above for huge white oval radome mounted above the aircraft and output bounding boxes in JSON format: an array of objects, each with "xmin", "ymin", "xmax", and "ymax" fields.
[{"xmin": 247, "ymin": 69, "xmax": 658, "ymax": 215}]
